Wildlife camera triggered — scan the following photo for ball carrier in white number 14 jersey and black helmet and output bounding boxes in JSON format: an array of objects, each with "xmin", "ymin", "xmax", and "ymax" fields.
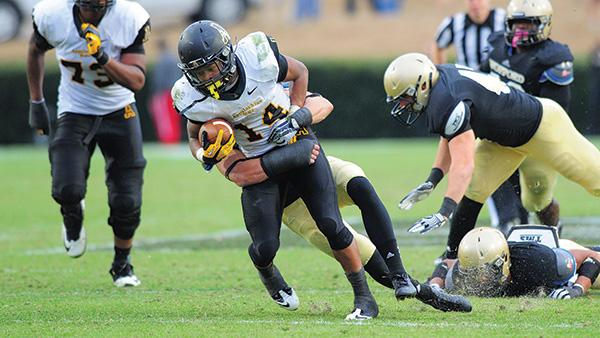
[{"xmin": 172, "ymin": 20, "xmax": 416, "ymax": 320}]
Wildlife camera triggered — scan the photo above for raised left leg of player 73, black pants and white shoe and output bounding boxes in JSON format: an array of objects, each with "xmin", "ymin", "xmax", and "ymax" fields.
[{"xmin": 49, "ymin": 114, "xmax": 95, "ymax": 258}]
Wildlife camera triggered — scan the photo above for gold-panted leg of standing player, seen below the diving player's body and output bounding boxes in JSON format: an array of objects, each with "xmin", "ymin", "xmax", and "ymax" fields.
[{"xmin": 519, "ymin": 157, "xmax": 560, "ymax": 231}]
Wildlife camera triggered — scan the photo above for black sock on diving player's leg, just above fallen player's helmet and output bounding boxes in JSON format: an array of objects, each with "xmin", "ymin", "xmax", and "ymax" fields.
[{"xmin": 446, "ymin": 197, "xmax": 483, "ymax": 258}]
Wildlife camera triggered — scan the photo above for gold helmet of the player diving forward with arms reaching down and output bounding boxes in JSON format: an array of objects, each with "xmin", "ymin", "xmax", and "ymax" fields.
[{"xmin": 383, "ymin": 53, "xmax": 439, "ymax": 126}]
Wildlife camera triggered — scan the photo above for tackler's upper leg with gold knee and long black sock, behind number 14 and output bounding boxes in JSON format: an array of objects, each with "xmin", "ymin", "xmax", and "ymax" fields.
[{"xmin": 327, "ymin": 156, "xmax": 417, "ymax": 299}]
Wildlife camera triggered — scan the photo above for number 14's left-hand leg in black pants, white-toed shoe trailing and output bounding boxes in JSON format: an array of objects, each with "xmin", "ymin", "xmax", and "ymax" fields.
[{"xmin": 242, "ymin": 180, "xmax": 300, "ymax": 310}]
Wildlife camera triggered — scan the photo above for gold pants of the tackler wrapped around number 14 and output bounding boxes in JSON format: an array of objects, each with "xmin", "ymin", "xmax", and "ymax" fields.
[{"xmin": 282, "ymin": 156, "xmax": 375, "ymax": 265}]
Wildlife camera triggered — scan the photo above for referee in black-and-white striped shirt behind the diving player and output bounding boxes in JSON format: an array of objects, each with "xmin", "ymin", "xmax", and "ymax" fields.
[{"xmin": 431, "ymin": 0, "xmax": 528, "ymax": 243}]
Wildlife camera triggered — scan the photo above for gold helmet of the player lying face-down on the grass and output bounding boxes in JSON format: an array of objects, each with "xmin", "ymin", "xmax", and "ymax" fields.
[{"xmin": 452, "ymin": 227, "xmax": 510, "ymax": 297}]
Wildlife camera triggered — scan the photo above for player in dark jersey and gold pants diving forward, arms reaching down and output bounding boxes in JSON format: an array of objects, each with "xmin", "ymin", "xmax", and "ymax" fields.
[{"xmin": 384, "ymin": 53, "xmax": 600, "ymax": 259}]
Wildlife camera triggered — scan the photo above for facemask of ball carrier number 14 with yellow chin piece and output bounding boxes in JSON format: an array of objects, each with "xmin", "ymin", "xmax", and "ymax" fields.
[{"xmin": 177, "ymin": 43, "xmax": 237, "ymax": 99}]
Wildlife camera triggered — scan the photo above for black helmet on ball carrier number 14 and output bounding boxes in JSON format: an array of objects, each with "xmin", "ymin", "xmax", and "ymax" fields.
[{"xmin": 177, "ymin": 20, "xmax": 237, "ymax": 99}]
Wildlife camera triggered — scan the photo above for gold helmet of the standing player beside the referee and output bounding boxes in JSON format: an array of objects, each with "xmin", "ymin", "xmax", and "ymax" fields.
[{"xmin": 504, "ymin": 0, "xmax": 553, "ymax": 48}]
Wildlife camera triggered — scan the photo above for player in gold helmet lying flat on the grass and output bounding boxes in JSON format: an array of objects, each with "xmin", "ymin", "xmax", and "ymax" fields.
[{"xmin": 429, "ymin": 227, "xmax": 600, "ymax": 299}]
